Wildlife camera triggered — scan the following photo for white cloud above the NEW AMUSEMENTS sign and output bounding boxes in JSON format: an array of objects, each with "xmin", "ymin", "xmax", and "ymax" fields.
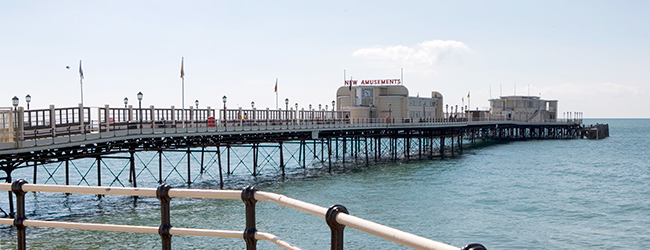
[{"xmin": 352, "ymin": 40, "xmax": 472, "ymax": 73}]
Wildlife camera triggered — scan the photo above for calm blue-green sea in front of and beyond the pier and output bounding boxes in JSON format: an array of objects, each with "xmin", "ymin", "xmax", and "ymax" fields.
[{"xmin": 0, "ymin": 119, "xmax": 650, "ymax": 249}]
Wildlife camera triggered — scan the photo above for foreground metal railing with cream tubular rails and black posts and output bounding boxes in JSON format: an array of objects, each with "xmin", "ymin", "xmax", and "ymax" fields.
[{"xmin": 0, "ymin": 179, "xmax": 485, "ymax": 250}]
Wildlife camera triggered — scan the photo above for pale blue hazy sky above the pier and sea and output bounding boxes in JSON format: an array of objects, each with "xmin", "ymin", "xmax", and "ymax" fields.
[{"xmin": 0, "ymin": 0, "xmax": 650, "ymax": 118}]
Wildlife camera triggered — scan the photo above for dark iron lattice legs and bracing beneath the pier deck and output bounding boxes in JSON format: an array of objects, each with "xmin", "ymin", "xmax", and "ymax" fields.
[{"xmin": 0, "ymin": 121, "xmax": 581, "ymax": 215}]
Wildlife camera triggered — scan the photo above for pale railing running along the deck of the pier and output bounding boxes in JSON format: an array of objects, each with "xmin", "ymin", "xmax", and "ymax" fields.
[{"xmin": 0, "ymin": 105, "xmax": 582, "ymax": 149}]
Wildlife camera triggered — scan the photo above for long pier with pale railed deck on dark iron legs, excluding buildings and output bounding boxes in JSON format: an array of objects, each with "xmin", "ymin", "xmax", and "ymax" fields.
[{"xmin": 0, "ymin": 102, "xmax": 585, "ymax": 249}]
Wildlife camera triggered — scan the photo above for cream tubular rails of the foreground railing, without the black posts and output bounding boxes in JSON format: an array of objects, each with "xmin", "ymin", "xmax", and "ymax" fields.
[{"xmin": 0, "ymin": 180, "xmax": 466, "ymax": 250}]
